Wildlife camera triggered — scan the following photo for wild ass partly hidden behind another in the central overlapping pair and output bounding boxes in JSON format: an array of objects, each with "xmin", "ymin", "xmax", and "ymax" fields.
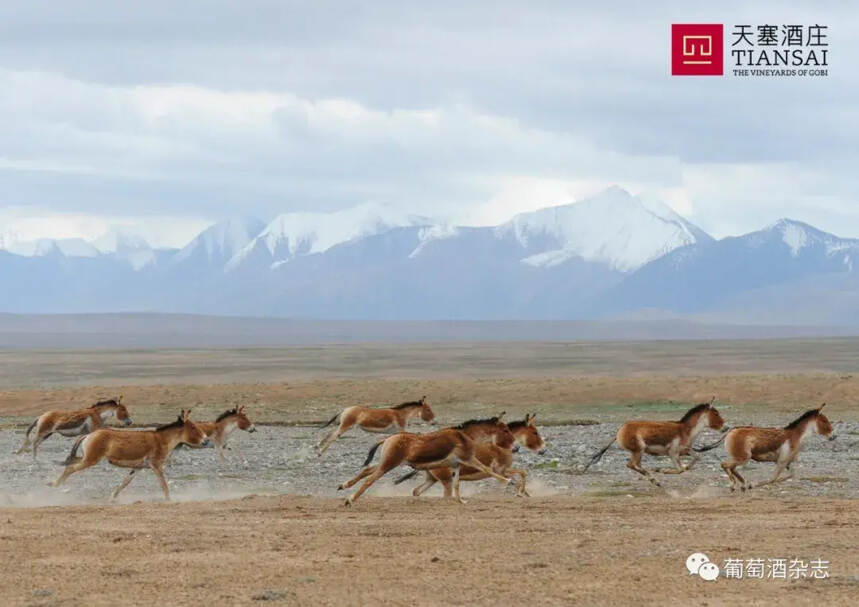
[{"xmin": 394, "ymin": 414, "xmax": 546, "ymax": 497}]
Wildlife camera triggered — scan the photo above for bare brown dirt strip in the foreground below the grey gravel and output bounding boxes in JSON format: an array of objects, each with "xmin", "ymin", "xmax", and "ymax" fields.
[{"xmin": 0, "ymin": 496, "xmax": 859, "ymax": 605}]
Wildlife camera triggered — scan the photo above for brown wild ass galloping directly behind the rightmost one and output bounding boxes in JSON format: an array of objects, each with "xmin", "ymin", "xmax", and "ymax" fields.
[{"xmin": 584, "ymin": 396, "xmax": 725, "ymax": 487}]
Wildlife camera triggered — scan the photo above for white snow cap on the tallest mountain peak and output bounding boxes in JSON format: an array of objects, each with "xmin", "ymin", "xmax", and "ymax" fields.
[{"xmin": 496, "ymin": 187, "xmax": 712, "ymax": 272}]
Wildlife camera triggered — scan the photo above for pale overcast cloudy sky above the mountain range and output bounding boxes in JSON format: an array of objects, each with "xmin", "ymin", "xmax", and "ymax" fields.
[{"xmin": 0, "ymin": 1, "xmax": 859, "ymax": 245}]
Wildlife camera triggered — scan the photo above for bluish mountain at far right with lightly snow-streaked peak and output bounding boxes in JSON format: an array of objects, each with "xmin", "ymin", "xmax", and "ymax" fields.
[{"xmin": 595, "ymin": 219, "xmax": 859, "ymax": 322}]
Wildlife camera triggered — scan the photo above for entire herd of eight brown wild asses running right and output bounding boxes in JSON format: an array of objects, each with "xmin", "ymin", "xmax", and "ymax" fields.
[{"xmin": 11, "ymin": 396, "xmax": 835, "ymax": 505}]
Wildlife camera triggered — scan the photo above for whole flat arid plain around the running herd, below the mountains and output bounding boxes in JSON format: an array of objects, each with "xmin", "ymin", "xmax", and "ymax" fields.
[{"xmin": 0, "ymin": 338, "xmax": 859, "ymax": 605}]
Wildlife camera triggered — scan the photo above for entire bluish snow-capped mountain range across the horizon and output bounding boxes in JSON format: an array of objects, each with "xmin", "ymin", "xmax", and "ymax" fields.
[{"xmin": 0, "ymin": 188, "xmax": 859, "ymax": 325}]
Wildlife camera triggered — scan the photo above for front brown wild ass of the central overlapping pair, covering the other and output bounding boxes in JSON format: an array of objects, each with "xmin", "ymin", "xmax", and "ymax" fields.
[{"xmin": 337, "ymin": 420, "xmax": 513, "ymax": 506}]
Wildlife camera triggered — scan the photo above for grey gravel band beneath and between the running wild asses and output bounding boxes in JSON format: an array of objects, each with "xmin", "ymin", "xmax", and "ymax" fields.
[{"xmin": 0, "ymin": 419, "xmax": 859, "ymax": 507}]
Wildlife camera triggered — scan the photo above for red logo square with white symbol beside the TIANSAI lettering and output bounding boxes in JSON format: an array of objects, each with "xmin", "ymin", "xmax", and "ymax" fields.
[{"xmin": 671, "ymin": 23, "xmax": 725, "ymax": 76}]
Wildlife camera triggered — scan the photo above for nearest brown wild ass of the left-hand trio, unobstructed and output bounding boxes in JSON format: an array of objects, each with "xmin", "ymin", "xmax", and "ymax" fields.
[{"xmin": 54, "ymin": 410, "xmax": 209, "ymax": 501}]
